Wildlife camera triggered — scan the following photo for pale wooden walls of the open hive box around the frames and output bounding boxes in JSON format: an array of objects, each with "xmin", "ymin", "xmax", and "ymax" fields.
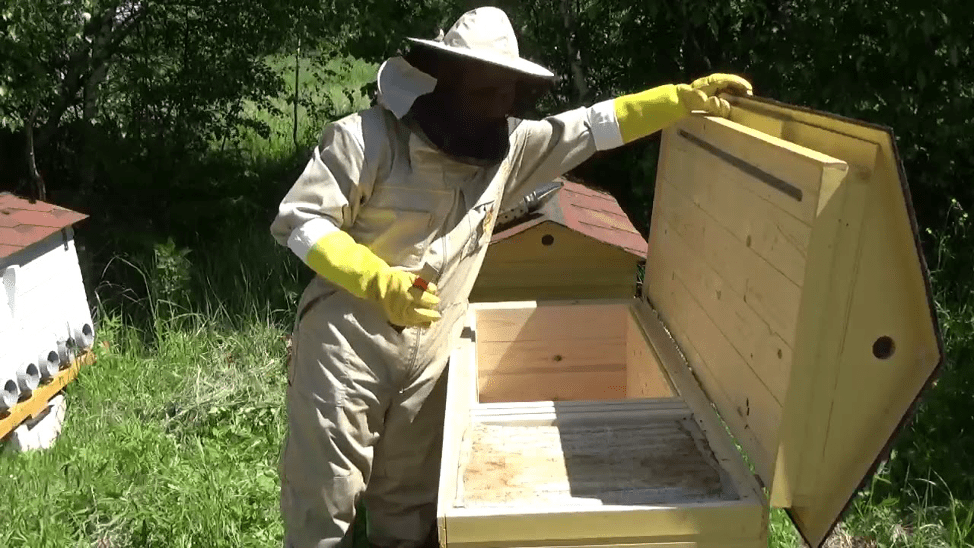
[{"xmin": 439, "ymin": 299, "xmax": 767, "ymax": 547}]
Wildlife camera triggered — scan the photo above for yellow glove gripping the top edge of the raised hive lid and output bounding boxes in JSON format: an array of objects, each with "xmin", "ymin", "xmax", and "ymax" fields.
[{"xmin": 614, "ymin": 73, "xmax": 753, "ymax": 143}]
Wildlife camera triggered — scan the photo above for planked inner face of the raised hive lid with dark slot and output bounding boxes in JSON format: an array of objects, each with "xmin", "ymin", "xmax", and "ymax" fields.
[{"xmin": 644, "ymin": 117, "xmax": 847, "ymax": 494}]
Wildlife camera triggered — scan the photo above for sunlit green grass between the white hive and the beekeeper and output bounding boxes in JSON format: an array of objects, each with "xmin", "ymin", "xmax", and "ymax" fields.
[{"xmin": 0, "ymin": 310, "xmax": 285, "ymax": 547}]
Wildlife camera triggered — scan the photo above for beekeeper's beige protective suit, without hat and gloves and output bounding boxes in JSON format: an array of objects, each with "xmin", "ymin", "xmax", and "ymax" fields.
[{"xmin": 272, "ymin": 61, "xmax": 622, "ymax": 547}]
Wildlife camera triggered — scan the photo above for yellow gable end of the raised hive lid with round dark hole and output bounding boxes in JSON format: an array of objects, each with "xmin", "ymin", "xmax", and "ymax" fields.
[{"xmin": 782, "ymin": 144, "xmax": 939, "ymax": 541}]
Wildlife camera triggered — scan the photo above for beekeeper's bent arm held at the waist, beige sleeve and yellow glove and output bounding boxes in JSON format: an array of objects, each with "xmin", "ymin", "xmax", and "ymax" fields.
[{"xmin": 271, "ymin": 116, "xmax": 440, "ymax": 326}]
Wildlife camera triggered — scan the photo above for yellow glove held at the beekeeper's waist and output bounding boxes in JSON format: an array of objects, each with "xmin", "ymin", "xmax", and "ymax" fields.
[{"xmin": 306, "ymin": 231, "xmax": 440, "ymax": 326}]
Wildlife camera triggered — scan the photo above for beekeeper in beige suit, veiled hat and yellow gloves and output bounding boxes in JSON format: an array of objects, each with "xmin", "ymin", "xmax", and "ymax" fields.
[{"xmin": 271, "ymin": 7, "xmax": 751, "ymax": 547}]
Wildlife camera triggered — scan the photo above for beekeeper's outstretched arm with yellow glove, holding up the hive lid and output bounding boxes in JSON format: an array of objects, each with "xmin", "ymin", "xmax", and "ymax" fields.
[{"xmin": 502, "ymin": 73, "xmax": 752, "ymax": 208}]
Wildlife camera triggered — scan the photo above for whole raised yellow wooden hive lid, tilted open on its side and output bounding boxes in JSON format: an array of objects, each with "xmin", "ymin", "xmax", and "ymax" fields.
[{"xmin": 643, "ymin": 97, "xmax": 943, "ymax": 547}]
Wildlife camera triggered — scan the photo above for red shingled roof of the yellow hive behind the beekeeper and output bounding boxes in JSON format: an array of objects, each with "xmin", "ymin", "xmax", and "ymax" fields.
[{"xmin": 491, "ymin": 179, "xmax": 648, "ymax": 258}]
